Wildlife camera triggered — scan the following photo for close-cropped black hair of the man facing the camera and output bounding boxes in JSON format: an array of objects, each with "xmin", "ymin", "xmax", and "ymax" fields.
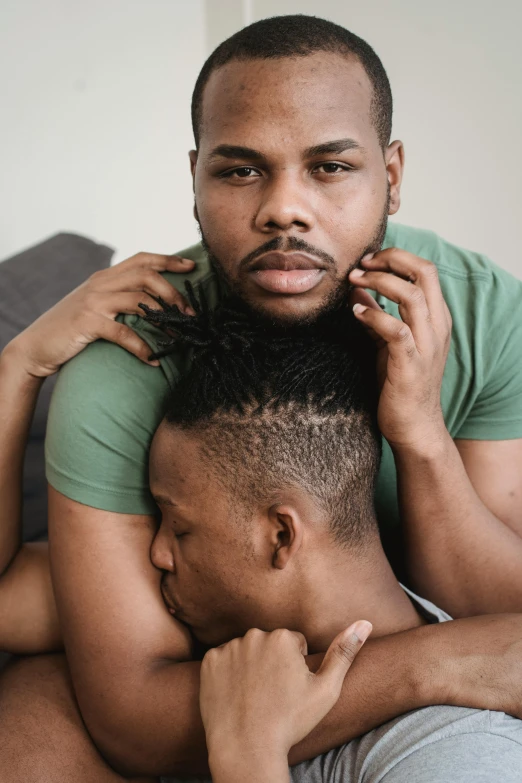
[{"xmin": 192, "ymin": 14, "xmax": 393, "ymax": 150}]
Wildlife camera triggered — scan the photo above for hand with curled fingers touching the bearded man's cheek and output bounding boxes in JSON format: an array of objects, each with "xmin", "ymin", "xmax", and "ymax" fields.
[{"xmin": 349, "ymin": 248, "xmax": 451, "ymax": 448}]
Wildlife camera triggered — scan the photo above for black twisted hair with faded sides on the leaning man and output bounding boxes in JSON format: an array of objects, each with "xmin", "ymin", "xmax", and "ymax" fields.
[{"xmin": 144, "ymin": 284, "xmax": 381, "ymax": 546}]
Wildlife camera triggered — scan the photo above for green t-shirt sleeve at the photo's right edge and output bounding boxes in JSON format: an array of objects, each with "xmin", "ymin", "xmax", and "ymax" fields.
[{"xmin": 454, "ymin": 262, "xmax": 522, "ymax": 440}]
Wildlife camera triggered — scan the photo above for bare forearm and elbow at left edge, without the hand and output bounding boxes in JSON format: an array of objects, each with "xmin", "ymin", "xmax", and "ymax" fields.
[{"xmin": 0, "ymin": 341, "xmax": 61, "ymax": 654}]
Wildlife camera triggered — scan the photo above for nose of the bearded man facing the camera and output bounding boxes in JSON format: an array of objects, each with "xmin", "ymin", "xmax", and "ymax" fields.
[{"xmin": 255, "ymin": 169, "xmax": 314, "ymax": 234}]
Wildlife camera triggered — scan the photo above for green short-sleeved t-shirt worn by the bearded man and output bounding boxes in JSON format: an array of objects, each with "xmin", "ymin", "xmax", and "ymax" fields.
[{"xmin": 46, "ymin": 223, "xmax": 522, "ymax": 538}]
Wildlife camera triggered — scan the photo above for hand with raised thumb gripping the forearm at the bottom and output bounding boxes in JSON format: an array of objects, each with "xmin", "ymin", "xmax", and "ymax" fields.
[{"xmin": 200, "ymin": 620, "xmax": 372, "ymax": 761}]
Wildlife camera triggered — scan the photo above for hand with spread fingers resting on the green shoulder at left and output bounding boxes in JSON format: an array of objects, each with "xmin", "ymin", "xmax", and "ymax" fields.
[{"xmin": 9, "ymin": 253, "xmax": 194, "ymax": 378}]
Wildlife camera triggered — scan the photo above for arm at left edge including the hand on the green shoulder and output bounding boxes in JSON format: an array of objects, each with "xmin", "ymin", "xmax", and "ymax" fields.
[{"xmin": 0, "ymin": 256, "xmax": 192, "ymax": 654}]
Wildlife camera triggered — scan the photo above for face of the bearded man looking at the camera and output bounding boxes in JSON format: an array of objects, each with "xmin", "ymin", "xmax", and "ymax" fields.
[{"xmin": 190, "ymin": 52, "xmax": 403, "ymax": 323}]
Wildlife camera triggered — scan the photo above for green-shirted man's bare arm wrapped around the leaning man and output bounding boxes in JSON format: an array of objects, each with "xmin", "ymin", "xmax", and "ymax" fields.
[{"xmin": 45, "ymin": 496, "xmax": 522, "ymax": 776}]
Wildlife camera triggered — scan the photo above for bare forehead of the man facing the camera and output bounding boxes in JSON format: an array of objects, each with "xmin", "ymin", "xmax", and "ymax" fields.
[{"xmin": 201, "ymin": 52, "xmax": 372, "ymax": 147}]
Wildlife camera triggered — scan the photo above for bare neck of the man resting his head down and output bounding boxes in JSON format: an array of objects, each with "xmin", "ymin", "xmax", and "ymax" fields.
[{"xmin": 294, "ymin": 536, "xmax": 425, "ymax": 653}]
